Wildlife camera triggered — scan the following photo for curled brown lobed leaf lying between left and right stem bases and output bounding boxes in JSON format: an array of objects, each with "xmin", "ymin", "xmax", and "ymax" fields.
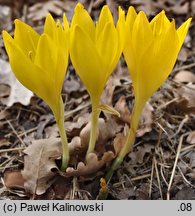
[{"xmin": 65, "ymin": 151, "xmax": 115, "ymax": 176}]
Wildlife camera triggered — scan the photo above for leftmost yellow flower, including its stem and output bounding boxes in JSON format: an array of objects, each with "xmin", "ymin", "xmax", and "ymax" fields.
[{"xmin": 3, "ymin": 14, "xmax": 69, "ymax": 170}]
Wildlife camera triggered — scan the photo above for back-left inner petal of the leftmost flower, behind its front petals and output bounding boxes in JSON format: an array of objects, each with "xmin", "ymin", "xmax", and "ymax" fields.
[{"xmin": 14, "ymin": 19, "xmax": 39, "ymax": 59}]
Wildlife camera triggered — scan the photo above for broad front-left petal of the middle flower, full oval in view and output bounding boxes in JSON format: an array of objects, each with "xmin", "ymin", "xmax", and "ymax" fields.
[{"xmin": 70, "ymin": 26, "xmax": 105, "ymax": 98}]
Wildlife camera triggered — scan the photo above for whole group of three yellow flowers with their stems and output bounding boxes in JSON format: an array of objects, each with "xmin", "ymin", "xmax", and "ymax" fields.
[{"xmin": 3, "ymin": 3, "xmax": 191, "ymax": 176}]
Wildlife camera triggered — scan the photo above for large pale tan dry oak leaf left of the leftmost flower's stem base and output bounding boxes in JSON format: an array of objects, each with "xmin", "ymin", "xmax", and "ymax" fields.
[{"xmin": 22, "ymin": 138, "xmax": 62, "ymax": 195}]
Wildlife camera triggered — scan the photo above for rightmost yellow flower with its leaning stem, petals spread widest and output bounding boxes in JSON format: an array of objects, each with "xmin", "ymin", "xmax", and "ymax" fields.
[{"xmin": 107, "ymin": 7, "xmax": 191, "ymax": 178}]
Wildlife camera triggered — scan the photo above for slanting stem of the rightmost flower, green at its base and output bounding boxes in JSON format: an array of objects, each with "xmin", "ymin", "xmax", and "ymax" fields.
[{"xmin": 105, "ymin": 103, "xmax": 143, "ymax": 181}]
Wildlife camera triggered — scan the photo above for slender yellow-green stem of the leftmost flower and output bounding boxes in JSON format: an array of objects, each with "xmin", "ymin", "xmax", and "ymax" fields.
[{"xmin": 56, "ymin": 98, "xmax": 70, "ymax": 171}]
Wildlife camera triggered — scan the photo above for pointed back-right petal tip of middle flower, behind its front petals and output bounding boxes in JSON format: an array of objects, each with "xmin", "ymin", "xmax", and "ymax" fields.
[{"xmin": 96, "ymin": 5, "xmax": 114, "ymax": 40}]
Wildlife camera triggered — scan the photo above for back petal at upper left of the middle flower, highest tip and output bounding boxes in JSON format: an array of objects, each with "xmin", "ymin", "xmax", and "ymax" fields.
[{"xmin": 71, "ymin": 3, "xmax": 95, "ymax": 40}]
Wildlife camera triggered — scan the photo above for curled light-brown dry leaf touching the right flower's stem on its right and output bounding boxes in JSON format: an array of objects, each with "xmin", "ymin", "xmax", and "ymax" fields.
[{"xmin": 136, "ymin": 103, "xmax": 154, "ymax": 137}]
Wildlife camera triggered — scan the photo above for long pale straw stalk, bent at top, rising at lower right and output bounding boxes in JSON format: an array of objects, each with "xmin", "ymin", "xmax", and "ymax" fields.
[{"xmin": 167, "ymin": 132, "xmax": 189, "ymax": 200}]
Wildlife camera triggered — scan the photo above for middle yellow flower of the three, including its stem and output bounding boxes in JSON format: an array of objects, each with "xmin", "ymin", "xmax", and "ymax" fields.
[{"xmin": 70, "ymin": 3, "xmax": 125, "ymax": 159}]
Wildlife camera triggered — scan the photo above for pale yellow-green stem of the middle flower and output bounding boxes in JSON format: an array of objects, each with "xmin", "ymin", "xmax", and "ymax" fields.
[{"xmin": 86, "ymin": 101, "xmax": 100, "ymax": 159}]
